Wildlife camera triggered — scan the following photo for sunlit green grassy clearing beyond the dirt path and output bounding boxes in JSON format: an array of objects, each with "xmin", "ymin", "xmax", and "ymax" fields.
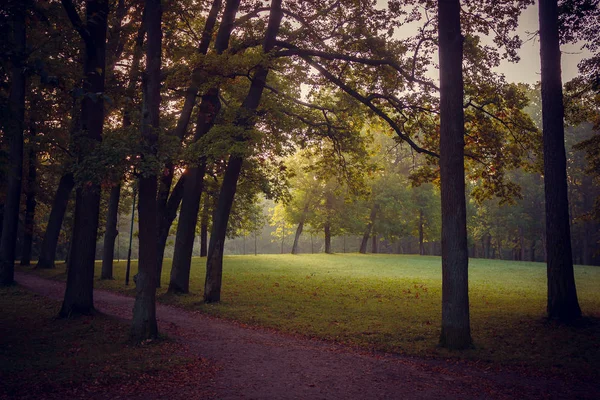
[{"xmin": 25, "ymin": 254, "xmax": 600, "ymax": 375}]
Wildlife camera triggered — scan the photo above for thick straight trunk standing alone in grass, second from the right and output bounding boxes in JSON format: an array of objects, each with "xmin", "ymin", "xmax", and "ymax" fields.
[{"xmin": 438, "ymin": 0, "xmax": 471, "ymax": 349}]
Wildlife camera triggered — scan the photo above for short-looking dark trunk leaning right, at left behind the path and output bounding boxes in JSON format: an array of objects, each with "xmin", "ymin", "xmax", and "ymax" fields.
[{"xmin": 37, "ymin": 172, "xmax": 75, "ymax": 268}]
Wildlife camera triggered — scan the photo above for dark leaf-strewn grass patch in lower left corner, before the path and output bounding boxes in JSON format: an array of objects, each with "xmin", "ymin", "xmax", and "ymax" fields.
[{"xmin": 0, "ymin": 286, "xmax": 195, "ymax": 398}]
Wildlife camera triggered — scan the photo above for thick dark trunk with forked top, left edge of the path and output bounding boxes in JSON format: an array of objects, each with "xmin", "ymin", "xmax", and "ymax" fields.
[{"xmin": 60, "ymin": 0, "xmax": 109, "ymax": 317}]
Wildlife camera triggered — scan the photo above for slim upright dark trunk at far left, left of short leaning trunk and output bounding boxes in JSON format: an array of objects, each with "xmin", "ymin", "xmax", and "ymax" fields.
[{"xmin": 21, "ymin": 126, "xmax": 37, "ymax": 265}]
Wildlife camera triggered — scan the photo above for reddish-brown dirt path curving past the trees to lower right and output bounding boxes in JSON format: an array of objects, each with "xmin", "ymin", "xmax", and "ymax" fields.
[{"xmin": 11, "ymin": 273, "xmax": 600, "ymax": 400}]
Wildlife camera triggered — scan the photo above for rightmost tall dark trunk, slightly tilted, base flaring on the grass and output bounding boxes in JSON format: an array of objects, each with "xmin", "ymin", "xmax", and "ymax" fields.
[{"xmin": 539, "ymin": 0, "xmax": 581, "ymax": 323}]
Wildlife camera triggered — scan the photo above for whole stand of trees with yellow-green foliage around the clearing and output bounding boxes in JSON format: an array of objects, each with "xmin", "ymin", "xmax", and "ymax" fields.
[{"xmin": 0, "ymin": 0, "xmax": 600, "ymax": 368}]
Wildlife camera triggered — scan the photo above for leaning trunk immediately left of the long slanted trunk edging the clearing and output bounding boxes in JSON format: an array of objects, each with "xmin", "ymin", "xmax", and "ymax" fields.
[{"xmin": 169, "ymin": 89, "xmax": 221, "ymax": 293}]
